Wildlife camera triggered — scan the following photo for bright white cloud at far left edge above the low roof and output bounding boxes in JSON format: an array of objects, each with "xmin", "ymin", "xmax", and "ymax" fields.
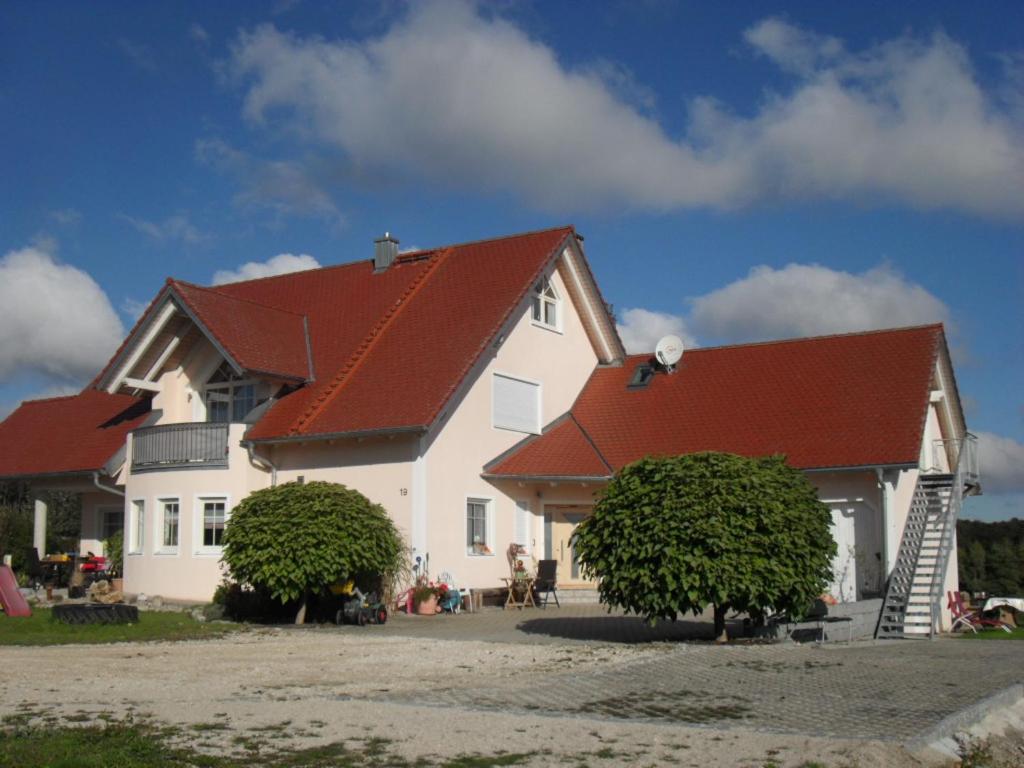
[{"xmin": 0, "ymin": 247, "xmax": 124, "ymax": 383}]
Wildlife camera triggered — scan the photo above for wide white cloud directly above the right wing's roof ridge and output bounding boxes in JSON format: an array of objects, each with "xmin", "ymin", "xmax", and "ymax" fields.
[{"xmin": 687, "ymin": 264, "xmax": 950, "ymax": 342}]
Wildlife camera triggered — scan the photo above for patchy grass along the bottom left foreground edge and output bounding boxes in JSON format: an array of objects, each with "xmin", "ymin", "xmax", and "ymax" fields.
[{"xmin": 0, "ymin": 721, "xmax": 531, "ymax": 768}]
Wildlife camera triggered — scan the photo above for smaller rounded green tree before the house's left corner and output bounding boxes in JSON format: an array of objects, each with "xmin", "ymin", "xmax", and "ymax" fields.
[{"xmin": 223, "ymin": 482, "xmax": 404, "ymax": 624}]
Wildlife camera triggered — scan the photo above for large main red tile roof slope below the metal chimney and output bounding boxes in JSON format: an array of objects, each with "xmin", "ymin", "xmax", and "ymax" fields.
[{"xmin": 211, "ymin": 227, "xmax": 572, "ymax": 440}]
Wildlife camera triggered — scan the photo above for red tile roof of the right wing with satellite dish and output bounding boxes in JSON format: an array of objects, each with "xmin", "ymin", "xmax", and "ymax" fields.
[{"xmin": 485, "ymin": 325, "xmax": 945, "ymax": 476}]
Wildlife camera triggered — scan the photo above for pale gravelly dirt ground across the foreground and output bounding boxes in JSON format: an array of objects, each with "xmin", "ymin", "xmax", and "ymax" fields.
[{"xmin": 0, "ymin": 630, "xmax": 1024, "ymax": 768}]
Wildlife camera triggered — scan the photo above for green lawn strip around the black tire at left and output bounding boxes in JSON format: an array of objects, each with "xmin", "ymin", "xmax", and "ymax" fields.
[{"xmin": 0, "ymin": 608, "xmax": 242, "ymax": 647}]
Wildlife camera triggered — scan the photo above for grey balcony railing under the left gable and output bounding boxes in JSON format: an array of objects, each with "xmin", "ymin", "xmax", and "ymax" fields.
[{"xmin": 131, "ymin": 422, "xmax": 230, "ymax": 472}]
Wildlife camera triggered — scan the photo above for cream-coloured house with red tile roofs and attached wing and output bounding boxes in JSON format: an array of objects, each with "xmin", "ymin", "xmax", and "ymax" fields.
[{"xmin": 0, "ymin": 227, "xmax": 977, "ymax": 632}]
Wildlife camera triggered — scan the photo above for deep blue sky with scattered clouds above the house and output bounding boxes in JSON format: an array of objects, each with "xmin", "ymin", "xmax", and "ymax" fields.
[{"xmin": 0, "ymin": 0, "xmax": 1024, "ymax": 518}]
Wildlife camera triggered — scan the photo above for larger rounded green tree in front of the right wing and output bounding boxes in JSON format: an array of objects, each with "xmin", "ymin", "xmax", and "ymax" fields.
[{"xmin": 575, "ymin": 453, "xmax": 836, "ymax": 640}]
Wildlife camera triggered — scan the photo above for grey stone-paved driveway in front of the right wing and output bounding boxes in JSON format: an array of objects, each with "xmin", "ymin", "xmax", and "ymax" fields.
[{"xmin": 346, "ymin": 606, "xmax": 1024, "ymax": 740}]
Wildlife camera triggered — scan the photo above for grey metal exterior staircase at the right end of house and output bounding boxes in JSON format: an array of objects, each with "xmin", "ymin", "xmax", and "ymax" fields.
[{"xmin": 874, "ymin": 435, "xmax": 978, "ymax": 638}]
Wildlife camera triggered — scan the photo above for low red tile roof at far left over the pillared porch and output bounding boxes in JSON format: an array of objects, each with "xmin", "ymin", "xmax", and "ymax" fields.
[{"xmin": 0, "ymin": 389, "xmax": 150, "ymax": 477}]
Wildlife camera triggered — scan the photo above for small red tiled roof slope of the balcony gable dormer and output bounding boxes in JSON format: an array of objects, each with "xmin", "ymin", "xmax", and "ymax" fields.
[{"xmin": 170, "ymin": 281, "xmax": 310, "ymax": 381}]
